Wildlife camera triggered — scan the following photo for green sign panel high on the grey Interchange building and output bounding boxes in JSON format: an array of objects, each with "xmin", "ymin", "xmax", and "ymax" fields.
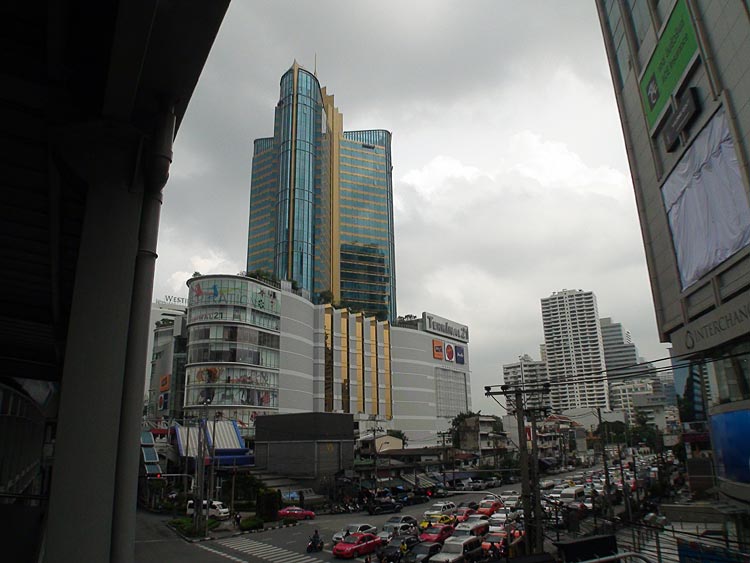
[{"xmin": 641, "ymin": 0, "xmax": 698, "ymax": 129}]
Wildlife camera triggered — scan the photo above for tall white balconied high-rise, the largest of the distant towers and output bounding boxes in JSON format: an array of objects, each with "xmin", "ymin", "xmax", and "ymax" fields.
[{"xmin": 542, "ymin": 289, "xmax": 609, "ymax": 413}]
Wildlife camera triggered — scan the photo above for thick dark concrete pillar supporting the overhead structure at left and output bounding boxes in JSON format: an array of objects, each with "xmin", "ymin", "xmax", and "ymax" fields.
[{"xmin": 43, "ymin": 125, "xmax": 146, "ymax": 563}]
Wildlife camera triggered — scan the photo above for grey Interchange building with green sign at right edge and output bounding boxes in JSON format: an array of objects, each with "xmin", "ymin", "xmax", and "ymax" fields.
[{"xmin": 596, "ymin": 0, "xmax": 750, "ymax": 512}]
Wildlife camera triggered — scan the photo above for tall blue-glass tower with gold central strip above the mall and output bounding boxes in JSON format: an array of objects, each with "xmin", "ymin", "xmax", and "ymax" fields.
[{"xmin": 247, "ymin": 62, "xmax": 396, "ymax": 320}]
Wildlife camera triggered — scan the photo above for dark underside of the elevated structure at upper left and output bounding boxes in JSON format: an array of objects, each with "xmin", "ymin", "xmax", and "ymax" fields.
[{"xmin": 0, "ymin": 0, "xmax": 229, "ymax": 388}]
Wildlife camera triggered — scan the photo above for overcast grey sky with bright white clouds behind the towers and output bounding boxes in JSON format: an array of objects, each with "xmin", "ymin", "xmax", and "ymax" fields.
[{"xmin": 154, "ymin": 0, "xmax": 668, "ymax": 414}]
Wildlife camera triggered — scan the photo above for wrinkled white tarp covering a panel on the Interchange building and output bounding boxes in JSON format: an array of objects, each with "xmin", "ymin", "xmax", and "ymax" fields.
[{"xmin": 662, "ymin": 109, "xmax": 750, "ymax": 289}]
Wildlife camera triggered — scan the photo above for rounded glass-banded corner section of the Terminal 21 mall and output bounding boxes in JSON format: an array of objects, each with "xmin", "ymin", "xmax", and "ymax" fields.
[{"xmin": 185, "ymin": 275, "xmax": 281, "ymax": 437}]
